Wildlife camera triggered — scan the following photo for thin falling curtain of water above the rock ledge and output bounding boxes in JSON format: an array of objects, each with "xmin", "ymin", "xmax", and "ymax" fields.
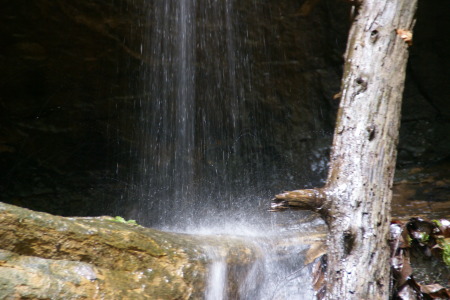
[{"xmin": 132, "ymin": 0, "xmax": 269, "ymax": 228}]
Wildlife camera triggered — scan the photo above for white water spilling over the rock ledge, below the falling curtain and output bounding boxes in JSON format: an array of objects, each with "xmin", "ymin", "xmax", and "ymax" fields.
[{"xmin": 195, "ymin": 219, "xmax": 325, "ymax": 300}]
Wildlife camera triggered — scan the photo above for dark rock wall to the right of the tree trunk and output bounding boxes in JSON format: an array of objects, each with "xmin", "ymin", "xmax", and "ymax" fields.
[{"xmin": 398, "ymin": 0, "xmax": 450, "ymax": 167}]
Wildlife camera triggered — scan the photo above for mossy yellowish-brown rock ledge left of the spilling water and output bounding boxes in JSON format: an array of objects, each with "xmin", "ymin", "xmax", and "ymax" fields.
[{"xmin": 0, "ymin": 203, "xmax": 264, "ymax": 299}]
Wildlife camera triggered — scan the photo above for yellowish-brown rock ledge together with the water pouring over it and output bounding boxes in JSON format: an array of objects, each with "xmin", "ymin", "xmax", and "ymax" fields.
[{"xmin": 0, "ymin": 203, "xmax": 325, "ymax": 299}]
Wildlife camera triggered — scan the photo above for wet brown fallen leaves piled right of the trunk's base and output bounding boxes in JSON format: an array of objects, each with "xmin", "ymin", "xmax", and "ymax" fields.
[{"xmin": 390, "ymin": 218, "xmax": 450, "ymax": 299}]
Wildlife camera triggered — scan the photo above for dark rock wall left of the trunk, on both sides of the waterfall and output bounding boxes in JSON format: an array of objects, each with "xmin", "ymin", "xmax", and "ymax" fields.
[{"xmin": 0, "ymin": 0, "xmax": 348, "ymax": 216}]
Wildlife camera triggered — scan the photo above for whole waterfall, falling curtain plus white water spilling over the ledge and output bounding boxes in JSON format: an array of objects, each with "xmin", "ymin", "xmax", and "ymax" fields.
[{"xmin": 123, "ymin": 0, "xmax": 330, "ymax": 300}]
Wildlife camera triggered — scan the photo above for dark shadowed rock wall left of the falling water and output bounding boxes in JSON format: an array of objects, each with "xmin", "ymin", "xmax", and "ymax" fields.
[{"xmin": 0, "ymin": 1, "xmax": 139, "ymax": 215}]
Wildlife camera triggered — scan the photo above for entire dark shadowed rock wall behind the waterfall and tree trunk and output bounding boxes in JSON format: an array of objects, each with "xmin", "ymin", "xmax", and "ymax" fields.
[{"xmin": 0, "ymin": 0, "xmax": 450, "ymax": 216}]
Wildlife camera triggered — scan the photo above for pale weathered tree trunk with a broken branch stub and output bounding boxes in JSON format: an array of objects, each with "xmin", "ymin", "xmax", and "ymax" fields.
[{"xmin": 272, "ymin": 0, "xmax": 417, "ymax": 299}]
